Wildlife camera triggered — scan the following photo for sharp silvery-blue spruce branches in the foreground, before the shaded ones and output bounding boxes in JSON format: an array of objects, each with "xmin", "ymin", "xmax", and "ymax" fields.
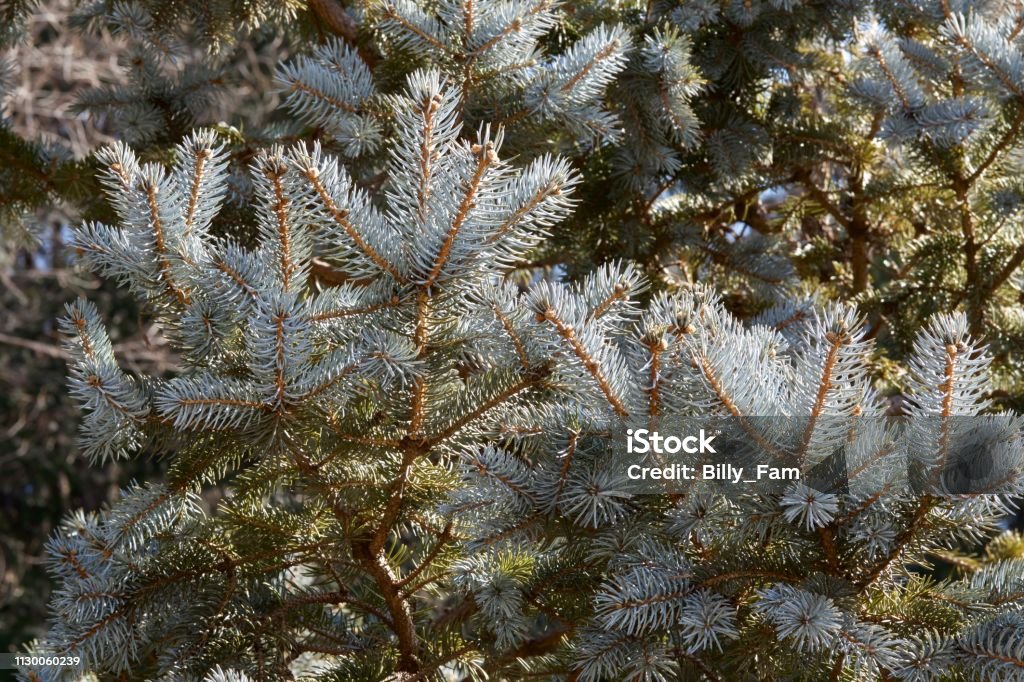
[{"xmin": 19, "ymin": 66, "xmax": 1024, "ymax": 681}]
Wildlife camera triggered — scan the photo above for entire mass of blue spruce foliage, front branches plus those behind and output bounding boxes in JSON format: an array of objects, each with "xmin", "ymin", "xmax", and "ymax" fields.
[{"xmin": 6, "ymin": 0, "xmax": 1024, "ymax": 682}]
